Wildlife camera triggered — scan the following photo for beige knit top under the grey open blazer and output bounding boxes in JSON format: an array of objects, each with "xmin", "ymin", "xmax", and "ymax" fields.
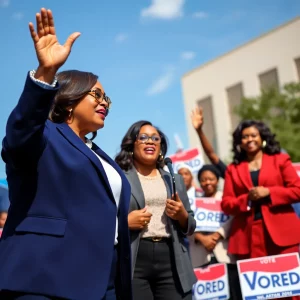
[{"xmin": 138, "ymin": 171, "xmax": 170, "ymax": 238}]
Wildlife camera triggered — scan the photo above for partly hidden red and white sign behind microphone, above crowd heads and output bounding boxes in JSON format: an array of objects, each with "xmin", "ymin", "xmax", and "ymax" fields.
[{"xmin": 170, "ymin": 148, "xmax": 203, "ymax": 173}]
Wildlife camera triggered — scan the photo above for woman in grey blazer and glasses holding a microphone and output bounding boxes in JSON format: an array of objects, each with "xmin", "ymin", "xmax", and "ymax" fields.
[{"xmin": 115, "ymin": 121, "xmax": 196, "ymax": 300}]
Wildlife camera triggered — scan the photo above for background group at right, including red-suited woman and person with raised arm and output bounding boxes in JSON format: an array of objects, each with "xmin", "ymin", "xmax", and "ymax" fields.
[{"xmin": 178, "ymin": 108, "xmax": 300, "ymax": 299}]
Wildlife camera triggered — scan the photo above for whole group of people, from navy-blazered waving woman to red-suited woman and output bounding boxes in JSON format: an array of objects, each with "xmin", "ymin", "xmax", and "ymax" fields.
[{"xmin": 0, "ymin": 9, "xmax": 300, "ymax": 300}]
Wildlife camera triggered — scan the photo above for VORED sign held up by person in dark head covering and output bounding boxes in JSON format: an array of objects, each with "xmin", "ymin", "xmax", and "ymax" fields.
[{"xmin": 194, "ymin": 197, "xmax": 229, "ymax": 232}]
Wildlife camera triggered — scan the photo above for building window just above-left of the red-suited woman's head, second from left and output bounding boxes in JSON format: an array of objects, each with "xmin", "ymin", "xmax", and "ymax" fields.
[{"xmin": 226, "ymin": 82, "xmax": 244, "ymax": 130}]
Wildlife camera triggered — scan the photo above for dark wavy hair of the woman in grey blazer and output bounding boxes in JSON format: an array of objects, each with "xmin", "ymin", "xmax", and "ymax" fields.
[{"xmin": 115, "ymin": 121, "xmax": 168, "ymax": 171}]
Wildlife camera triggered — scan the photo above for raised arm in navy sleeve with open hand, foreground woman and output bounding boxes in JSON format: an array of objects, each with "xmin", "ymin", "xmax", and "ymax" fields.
[{"xmin": 3, "ymin": 8, "xmax": 80, "ymax": 155}]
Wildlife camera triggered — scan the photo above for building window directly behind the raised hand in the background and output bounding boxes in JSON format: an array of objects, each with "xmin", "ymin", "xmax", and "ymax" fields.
[{"xmin": 198, "ymin": 96, "xmax": 217, "ymax": 162}]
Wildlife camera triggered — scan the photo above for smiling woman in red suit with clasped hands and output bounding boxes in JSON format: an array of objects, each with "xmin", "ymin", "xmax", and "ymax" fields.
[{"xmin": 221, "ymin": 120, "xmax": 300, "ymax": 299}]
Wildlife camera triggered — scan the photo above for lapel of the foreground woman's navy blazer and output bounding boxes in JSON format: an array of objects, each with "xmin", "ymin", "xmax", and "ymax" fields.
[{"xmin": 57, "ymin": 123, "xmax": 115, "ymax": 202}]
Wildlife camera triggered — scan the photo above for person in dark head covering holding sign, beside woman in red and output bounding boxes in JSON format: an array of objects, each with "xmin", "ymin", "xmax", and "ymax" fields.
[{"xmin": 190, "ymin": 165, "xmax": 242, "ymax": 300}]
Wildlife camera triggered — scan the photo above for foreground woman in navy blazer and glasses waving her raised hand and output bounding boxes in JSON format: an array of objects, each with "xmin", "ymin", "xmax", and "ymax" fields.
[{"xmin": 0, "ymin": 8, "xmax": 132, "ymax": 300}]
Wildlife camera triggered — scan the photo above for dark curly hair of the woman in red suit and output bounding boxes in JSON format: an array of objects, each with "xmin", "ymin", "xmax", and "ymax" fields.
[{"xmin": 232, "ymin": 120, "xmax": 281, "ymax": 164}]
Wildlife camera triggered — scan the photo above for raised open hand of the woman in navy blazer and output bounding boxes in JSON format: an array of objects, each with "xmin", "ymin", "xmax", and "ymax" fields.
[{"xmin": 29, "ymin": 8, "xmax": 80, "ymax": 83}]
